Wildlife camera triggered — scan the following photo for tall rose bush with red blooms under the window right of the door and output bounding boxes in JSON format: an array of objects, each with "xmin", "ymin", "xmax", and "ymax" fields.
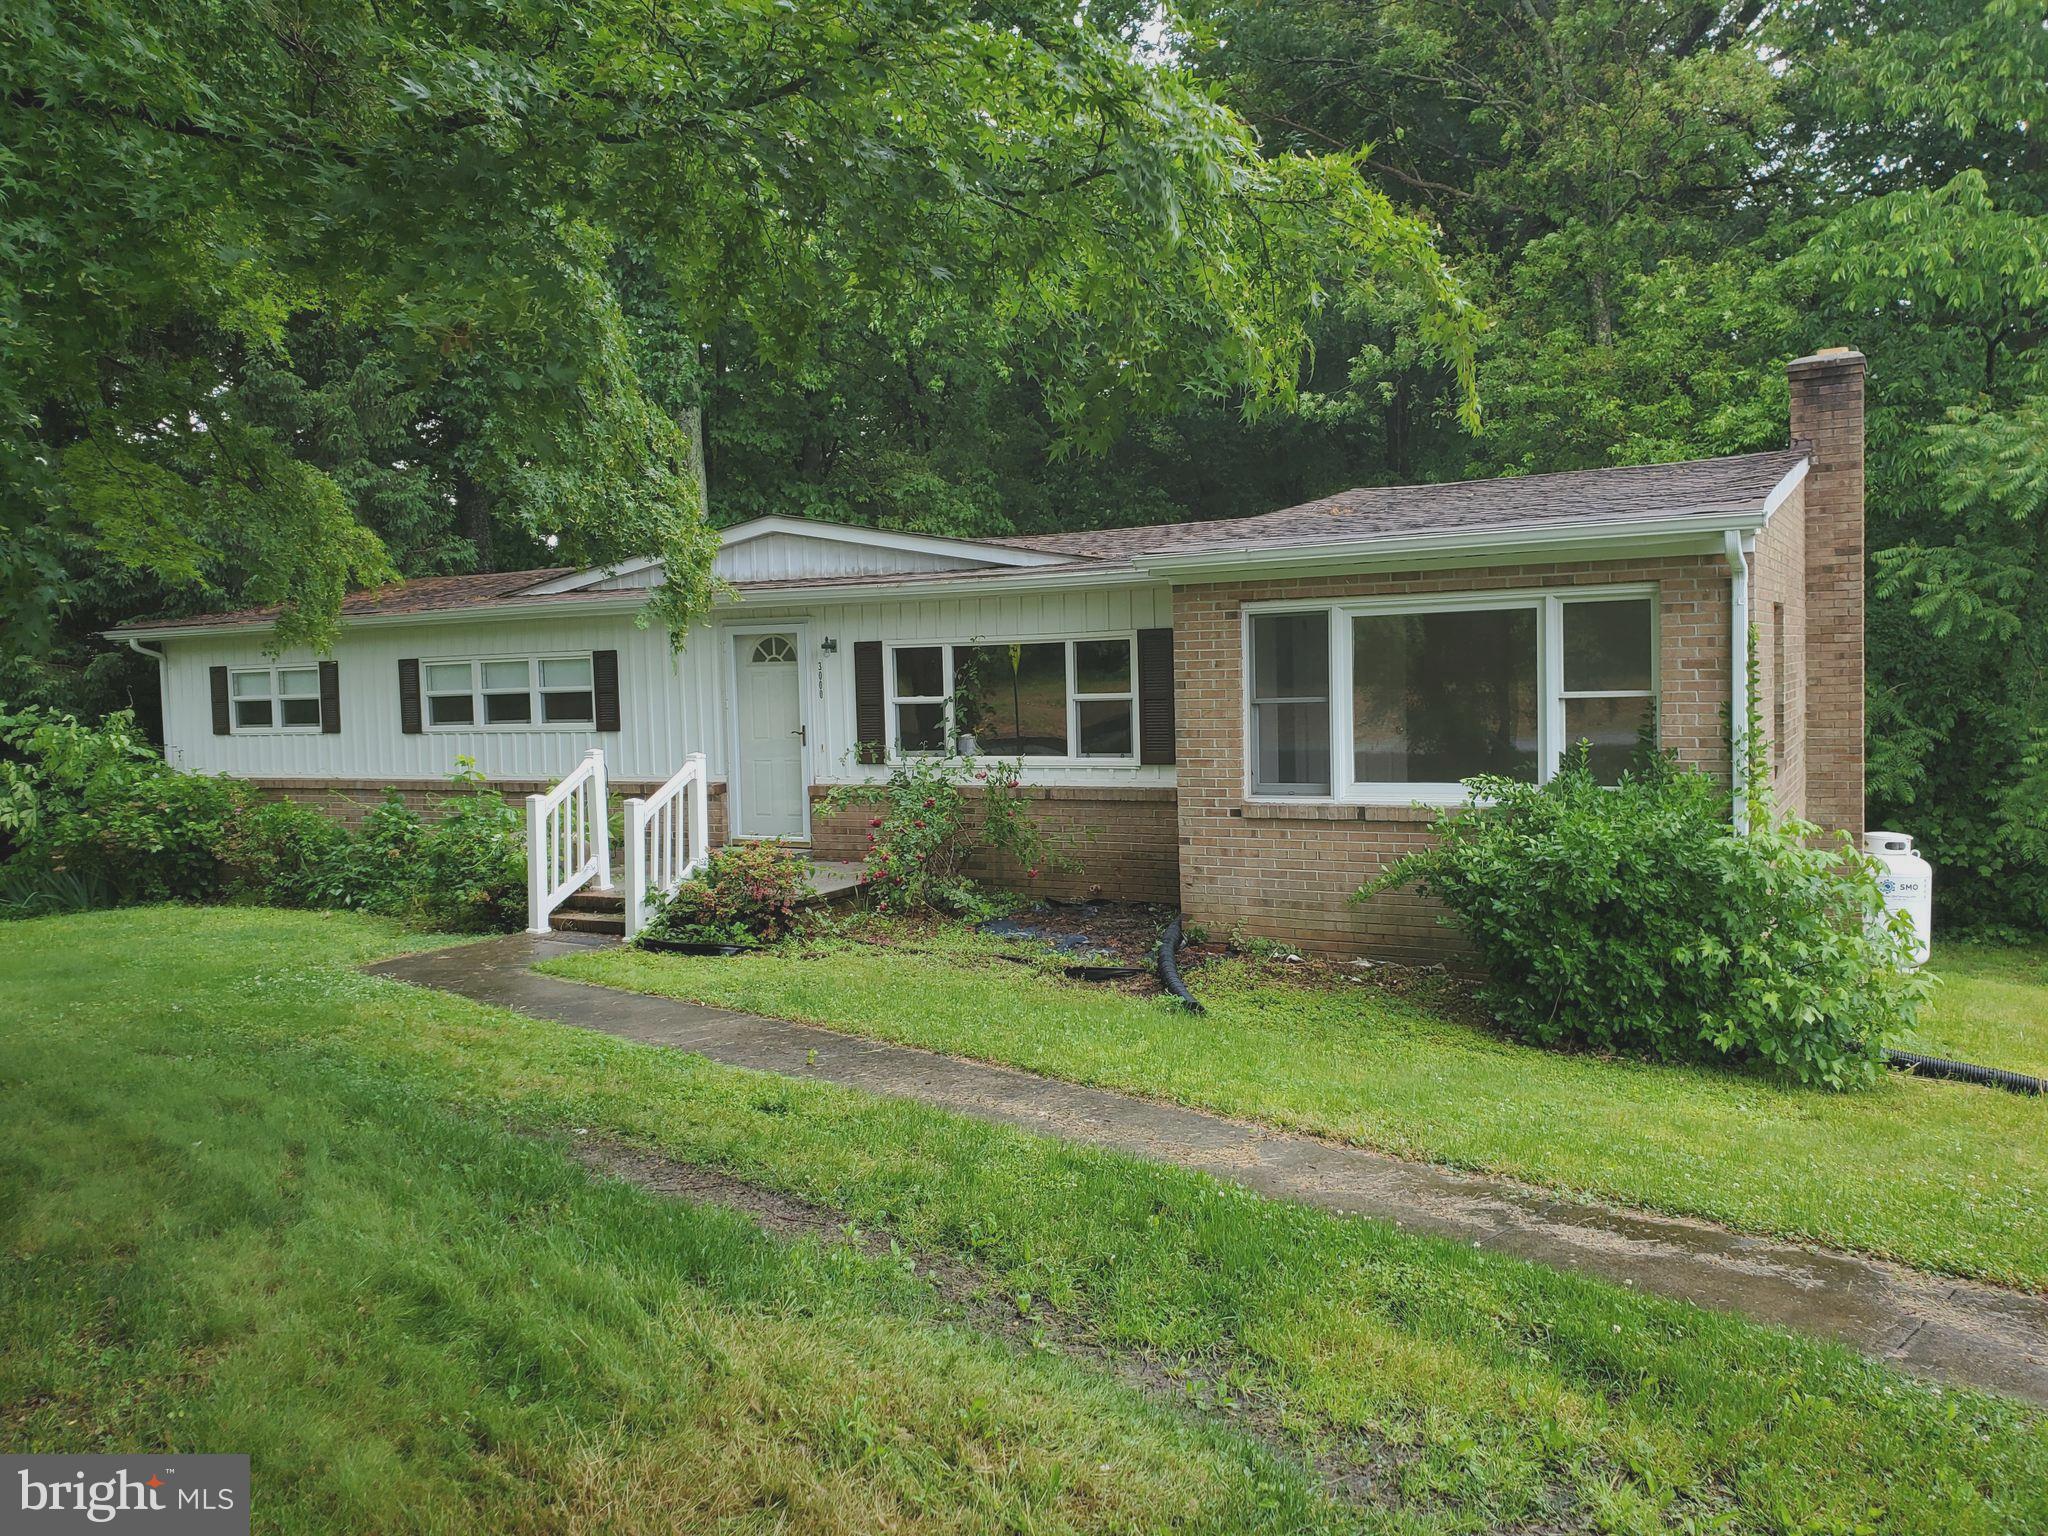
[{"xmin": 825, "ymin": 756, "xmax": 1067, "ymax": 911}]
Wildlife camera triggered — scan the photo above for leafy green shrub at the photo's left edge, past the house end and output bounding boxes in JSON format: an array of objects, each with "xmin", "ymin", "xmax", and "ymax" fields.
[{"xmin": 0, "ymin": 709, "xmax": 250, "ymax": 901}]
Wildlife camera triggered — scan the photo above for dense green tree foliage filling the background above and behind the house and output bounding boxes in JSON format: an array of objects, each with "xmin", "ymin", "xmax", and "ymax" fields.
[{"xmin": 0, "ymin": 0, "xmax": 2048, "ymax": 928}]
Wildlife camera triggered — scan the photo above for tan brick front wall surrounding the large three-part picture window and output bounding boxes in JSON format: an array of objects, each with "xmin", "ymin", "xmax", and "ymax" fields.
[{"xmin": 1174, "ymin": 555, "xmax": 1731, "ymax": 961}]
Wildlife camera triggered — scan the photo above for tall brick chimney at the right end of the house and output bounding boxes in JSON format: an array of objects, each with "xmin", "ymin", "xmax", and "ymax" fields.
[{"xmin": 1786, "ymin": 346, "xmax": 1864, "ymax": 838}]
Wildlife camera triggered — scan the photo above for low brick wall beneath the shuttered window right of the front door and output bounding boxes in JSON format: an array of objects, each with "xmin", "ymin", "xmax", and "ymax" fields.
[{"xmin": 811, "ymin": 784, "xmax": 1180, "ymax": 905}]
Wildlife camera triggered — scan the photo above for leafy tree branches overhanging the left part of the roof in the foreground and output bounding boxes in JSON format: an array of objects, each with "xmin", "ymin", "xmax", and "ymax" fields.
[{"xmin": 0, "ymin": 0, "xmax": 1466, "ymax": 649}]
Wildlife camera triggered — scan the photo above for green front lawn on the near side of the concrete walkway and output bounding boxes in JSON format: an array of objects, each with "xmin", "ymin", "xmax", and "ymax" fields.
[{"xmin": 0, "ymin": 909, "xmax": 2048, "ymax": 1536}]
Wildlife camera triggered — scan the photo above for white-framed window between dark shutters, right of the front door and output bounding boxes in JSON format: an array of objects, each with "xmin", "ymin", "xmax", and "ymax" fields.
[{"xmin": 887, "ymin": 635, "xmax": 1137, "ymax": 762}]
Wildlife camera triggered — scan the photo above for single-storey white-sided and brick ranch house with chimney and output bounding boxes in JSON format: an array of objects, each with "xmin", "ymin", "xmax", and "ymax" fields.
[{"xmin": 111, "ymin": 348, "xmax": 1864, "ymax": 958}]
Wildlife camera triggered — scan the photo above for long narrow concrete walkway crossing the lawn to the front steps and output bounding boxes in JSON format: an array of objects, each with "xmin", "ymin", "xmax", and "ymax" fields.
[{"xmin": 371, "ymin": 934, "xmax": 2048, "ymax": 1403}]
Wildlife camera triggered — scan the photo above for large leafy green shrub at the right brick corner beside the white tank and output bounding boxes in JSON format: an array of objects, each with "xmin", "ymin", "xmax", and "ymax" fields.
[{"xmin": 1356, "ymin": 756, "xmax": 1927, "ymax": 1087}]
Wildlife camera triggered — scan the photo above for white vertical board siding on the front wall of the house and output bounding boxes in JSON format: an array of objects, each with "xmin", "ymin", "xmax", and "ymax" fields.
[{"xmin": 160, "ymin": 577, "xmax": 1174, "ymax": 784}]
